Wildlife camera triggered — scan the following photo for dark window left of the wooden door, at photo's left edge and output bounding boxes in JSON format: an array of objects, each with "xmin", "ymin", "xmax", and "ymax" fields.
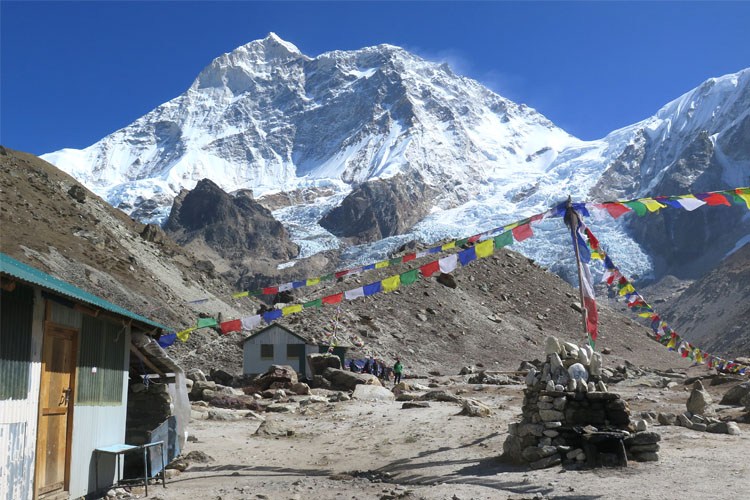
[{"xmin": 0, "ymin": 284, "xmax": 34, "ymax": 400}]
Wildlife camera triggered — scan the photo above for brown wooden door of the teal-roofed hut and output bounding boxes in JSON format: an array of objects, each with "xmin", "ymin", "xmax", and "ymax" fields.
[{"xmin": 34, "ymin": 322, "xmax": 78, "ymax": 498}]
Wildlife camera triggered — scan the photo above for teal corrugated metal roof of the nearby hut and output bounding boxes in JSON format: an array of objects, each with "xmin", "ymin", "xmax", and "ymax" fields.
[{"xmin": 0, "ymin": 253, "xmax": 172, "ymax": 330}]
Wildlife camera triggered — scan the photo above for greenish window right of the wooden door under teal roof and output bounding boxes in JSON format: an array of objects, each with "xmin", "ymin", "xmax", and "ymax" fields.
[{"xmin": 76, "ymin": 315, "xmax": 127, "ymax": 406}]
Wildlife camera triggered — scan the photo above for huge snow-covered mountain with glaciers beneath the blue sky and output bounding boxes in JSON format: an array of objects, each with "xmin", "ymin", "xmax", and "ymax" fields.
[{"xmin": 43, "ymin": 34, "xmax": 750, "ymax": 282}]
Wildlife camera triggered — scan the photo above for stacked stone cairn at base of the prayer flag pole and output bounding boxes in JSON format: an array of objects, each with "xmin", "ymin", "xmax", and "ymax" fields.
[{"xmin": 503, "ymin": 337, "xmax": 660, "ymax": 469}]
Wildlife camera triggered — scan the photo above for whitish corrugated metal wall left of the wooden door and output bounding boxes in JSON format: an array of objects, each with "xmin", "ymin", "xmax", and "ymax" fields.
[{"xmin": 0, "ymin": 288, "xmax": 44, "ymax": 500}]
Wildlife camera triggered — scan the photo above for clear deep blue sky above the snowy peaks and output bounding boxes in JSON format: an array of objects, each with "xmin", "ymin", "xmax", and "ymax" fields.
[{"xmin": 0, "ymin": 1, "xmax": 750, "ymax": 154}]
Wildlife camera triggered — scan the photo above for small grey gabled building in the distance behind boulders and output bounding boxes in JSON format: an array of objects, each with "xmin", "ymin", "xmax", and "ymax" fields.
[{"xmin": 242, "ymin": 323, "xmax": 347, "ymax": 377}]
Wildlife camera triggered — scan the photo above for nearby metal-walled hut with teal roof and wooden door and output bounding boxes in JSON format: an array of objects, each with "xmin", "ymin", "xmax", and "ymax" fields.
[{"xmin": 0, "ymin": 254, "xmax": 179, "ymax": 500}]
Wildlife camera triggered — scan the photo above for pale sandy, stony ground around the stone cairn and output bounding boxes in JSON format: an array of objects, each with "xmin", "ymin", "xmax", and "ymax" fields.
[{"xmin": 113, "ymin": 367, "xmax": 750, "ymax": 500}]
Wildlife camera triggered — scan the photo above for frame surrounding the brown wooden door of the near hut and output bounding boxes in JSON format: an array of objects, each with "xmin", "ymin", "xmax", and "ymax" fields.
[{"xmin": 33, "ymin": 300, "xmax": 80, "ymax": 499}]
